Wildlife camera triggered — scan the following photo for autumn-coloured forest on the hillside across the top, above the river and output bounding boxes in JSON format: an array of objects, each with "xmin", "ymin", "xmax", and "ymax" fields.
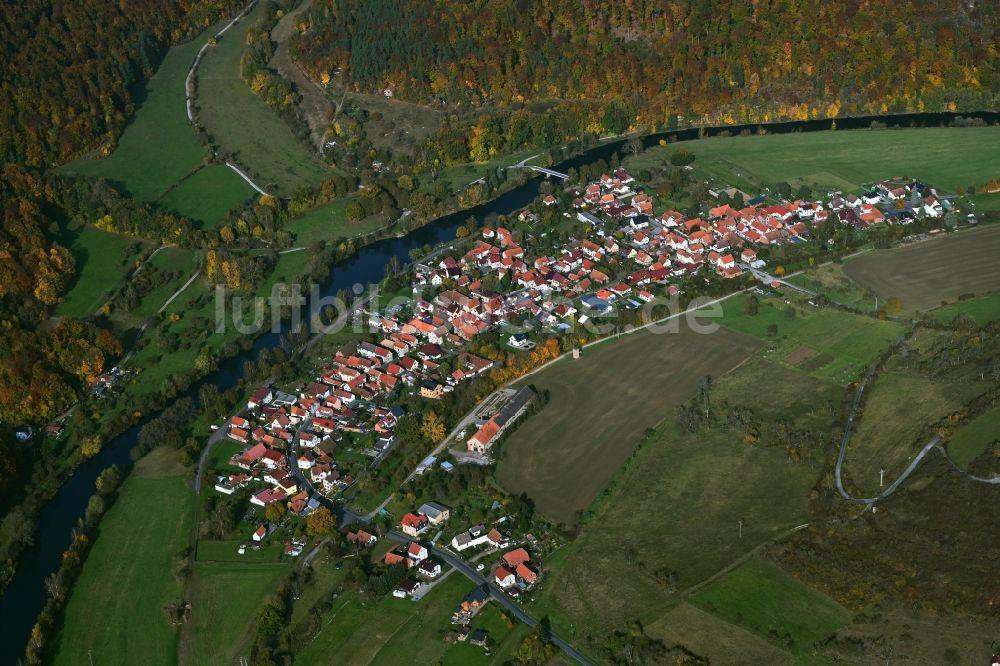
[{"xmin": 290, "ymin": 0, "xmax": 1000, "ymax": 159}]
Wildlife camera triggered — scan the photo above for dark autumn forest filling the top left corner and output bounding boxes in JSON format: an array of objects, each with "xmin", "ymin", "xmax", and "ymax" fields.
[{"xmin": 0, "ymin": 0, "xmax": 240, "ymax": 167}]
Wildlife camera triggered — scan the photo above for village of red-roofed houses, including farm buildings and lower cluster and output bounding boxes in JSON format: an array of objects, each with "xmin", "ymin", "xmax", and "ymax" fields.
[{"xmin": 207, "ymin": 169, "xmax": 947, "ymax": 646}]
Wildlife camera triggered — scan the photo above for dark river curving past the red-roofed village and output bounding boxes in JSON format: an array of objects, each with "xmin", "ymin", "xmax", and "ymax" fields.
[{"xmin": 0, "ymin": 112, "xmax": 1000, "ymax": 664}]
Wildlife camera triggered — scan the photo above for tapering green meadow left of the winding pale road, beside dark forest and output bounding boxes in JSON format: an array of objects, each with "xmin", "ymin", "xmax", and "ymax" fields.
[{"xmin": 64, "ymin": 28, "xmax": 217, "ymax": 201}]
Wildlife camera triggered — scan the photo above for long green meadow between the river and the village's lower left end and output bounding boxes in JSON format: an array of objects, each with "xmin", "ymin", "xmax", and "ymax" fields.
[{"xmin": 53, "ymin": 450, "xmax": 193, "ymax": 665}]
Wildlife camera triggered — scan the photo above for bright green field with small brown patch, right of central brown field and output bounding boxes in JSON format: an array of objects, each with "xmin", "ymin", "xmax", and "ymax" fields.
[{"xmin": 700, "ymin": 293, "xmax": 905, "ymax": 384}]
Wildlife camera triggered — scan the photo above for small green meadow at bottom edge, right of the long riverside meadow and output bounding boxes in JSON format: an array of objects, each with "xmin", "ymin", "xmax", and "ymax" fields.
[{"xmin": 180, "ymin": 562, "xmax": 288, "ymax": 664}]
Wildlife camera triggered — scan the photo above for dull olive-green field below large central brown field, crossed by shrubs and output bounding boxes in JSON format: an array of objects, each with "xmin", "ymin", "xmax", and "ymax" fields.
[{"xmin": 532, "ymin": 355, "xmax": 842, "ymax": 637}]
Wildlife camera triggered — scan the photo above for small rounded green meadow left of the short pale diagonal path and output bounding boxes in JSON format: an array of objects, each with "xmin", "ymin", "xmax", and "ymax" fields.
[{"xmin": 157, "ymin": 164, "xmax": 256, "ymax": 229}]
